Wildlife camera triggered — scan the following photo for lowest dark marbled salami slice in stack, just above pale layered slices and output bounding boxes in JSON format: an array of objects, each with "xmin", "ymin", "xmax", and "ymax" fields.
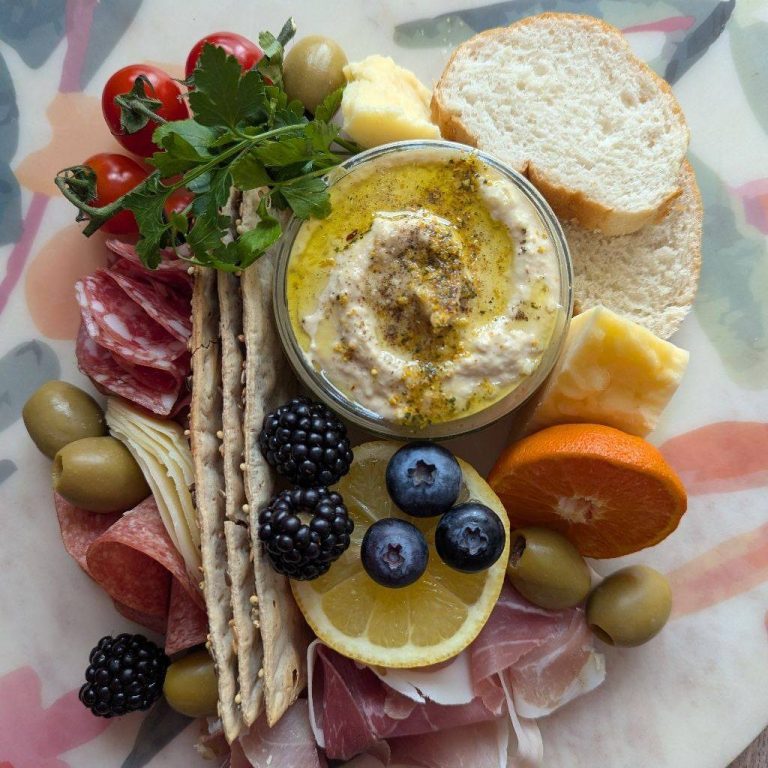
[{"xmin": 75, "ymin": 323, "xmax": 182, "ymax": 416}]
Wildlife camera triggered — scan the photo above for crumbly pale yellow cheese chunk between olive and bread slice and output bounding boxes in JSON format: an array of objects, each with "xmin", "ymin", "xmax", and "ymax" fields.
[{"xmin": 341, "ymin": 54, "xmax": 440, "ymax": 147}]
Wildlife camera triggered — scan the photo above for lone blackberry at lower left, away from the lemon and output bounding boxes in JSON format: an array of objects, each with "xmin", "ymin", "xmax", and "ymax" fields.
[{"xmin": 79, "ymin": 634, "xmax": 170, "ymax": 717}]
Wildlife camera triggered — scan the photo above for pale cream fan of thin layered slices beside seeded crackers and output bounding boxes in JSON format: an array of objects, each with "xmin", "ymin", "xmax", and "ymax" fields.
[{"xmin": 106, "ymin": 397, "xmax": 201, "ymax": 581}]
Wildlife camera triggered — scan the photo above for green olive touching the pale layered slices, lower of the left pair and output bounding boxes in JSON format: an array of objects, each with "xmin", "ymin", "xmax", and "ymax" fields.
[{"xmin": 53, "ymin": 437, "xmax": 150, "ymax": 512}]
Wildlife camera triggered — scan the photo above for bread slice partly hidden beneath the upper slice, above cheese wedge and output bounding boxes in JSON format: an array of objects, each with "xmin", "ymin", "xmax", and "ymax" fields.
[{"xmin": 563, "ymin": 161, "xmax": 702, "ymax": 339}]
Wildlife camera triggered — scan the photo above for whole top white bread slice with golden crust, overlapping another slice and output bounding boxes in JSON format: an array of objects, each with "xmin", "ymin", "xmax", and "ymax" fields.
[{"xmin": 432, "ymin": 13, "xmax": 688, "ymax": 235}]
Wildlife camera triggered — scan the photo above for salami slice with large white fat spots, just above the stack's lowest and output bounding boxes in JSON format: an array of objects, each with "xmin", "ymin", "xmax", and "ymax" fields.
[{"xmin": 78, "ymin": 270, "xmax": 186, "ymax": 370}]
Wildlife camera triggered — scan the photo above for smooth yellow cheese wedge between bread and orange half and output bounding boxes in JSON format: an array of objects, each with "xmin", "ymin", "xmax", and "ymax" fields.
[{"xmin": 527, "ymin": 306, "xmax": 688, "ymax": 437}]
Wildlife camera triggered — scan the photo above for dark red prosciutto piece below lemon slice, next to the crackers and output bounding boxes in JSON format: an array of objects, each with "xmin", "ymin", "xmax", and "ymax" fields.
[{"xmin": 310, "ymin": 644, "xmax": 501, "ymax": 760}]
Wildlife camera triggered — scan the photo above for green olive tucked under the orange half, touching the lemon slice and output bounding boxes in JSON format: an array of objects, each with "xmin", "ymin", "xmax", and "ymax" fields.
[{"xmin": 507, "ymin": 528, "xmax": 591, "ymax": 611}]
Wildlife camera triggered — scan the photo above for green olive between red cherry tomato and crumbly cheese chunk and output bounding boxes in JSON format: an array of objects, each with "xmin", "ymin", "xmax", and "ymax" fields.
[{"xmin": 283, "ymin": 35, "xmax": 347, "ymax": 113}]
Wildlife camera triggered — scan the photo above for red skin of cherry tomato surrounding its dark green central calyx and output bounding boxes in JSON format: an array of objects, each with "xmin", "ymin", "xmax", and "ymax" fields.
[{"xmin": 101, "ymin": 64, "xmax": 189, "ymax": 157}]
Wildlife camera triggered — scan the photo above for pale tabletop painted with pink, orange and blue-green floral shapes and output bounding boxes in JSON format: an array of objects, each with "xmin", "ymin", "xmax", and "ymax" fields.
[{"xmin": 0, "ymin": 0, "xmax": 768, "ymax": 768}]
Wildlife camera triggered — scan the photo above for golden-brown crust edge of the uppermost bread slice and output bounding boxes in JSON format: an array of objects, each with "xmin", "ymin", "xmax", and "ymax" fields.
[{"xmin": 431, "ymin": 12, "xmax": 690, "ymax": 236}]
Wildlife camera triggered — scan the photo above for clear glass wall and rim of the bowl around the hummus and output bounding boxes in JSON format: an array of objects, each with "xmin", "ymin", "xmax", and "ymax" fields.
[{"xmin": 274, "ymin": 140, "xmax": 573, "ymax": 440}]
